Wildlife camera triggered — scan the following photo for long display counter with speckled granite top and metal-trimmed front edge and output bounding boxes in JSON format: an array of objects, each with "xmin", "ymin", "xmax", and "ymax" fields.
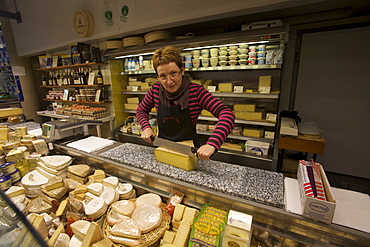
[{"xmin": 54, "ymin": 139, "xmax": 370, "ymax": 246}]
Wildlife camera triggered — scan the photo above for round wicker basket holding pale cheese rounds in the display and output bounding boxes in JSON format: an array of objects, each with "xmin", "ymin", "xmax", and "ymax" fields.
[{"xmin": 103, "ymin": 208, "xmax": 171, "ymax": 247}]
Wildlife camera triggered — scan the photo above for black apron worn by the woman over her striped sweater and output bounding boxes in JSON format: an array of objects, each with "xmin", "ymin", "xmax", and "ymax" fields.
[{"xmin": 157, "ymin": 102, "xmax": 200, "ymax": 147}]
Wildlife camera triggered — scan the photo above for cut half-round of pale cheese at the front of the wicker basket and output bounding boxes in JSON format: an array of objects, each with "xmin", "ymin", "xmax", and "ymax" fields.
[{"xmin": 109, "ymin": 218, "xmax": 141, "ymax": 238}]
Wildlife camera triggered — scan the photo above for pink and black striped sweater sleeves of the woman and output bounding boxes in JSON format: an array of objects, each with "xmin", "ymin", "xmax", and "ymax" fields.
[{"xmin": 136, "ymin": 82, "xmax": 235, "ymax": 149}]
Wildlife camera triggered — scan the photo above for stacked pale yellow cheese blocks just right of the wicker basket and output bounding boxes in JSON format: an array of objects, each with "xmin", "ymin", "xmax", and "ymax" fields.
[{"xmin": 161, "ymin": 203, "xmax": 199, "ymax": 247}]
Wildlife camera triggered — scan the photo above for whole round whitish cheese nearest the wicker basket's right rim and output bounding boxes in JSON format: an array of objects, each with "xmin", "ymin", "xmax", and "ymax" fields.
[{"xmin": 131, "ymin": 204, "xmax": 162, "ymax": 233}]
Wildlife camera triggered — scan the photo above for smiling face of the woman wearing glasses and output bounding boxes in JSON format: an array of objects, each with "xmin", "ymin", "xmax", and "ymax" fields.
[{"xmin": 157, "ymin": 62, "xmax": 185, "ymax": 93}]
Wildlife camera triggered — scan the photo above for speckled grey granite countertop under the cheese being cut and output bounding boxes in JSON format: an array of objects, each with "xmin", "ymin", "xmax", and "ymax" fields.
[{"xmin": 99, "ymin": 143, "xmax": 284, "ymax": 208}]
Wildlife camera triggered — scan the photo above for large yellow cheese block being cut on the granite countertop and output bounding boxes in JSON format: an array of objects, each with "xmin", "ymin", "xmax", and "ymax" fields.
[{"xmin": 154, "ymin": 147, "xmax": 198, "ymax": 171}]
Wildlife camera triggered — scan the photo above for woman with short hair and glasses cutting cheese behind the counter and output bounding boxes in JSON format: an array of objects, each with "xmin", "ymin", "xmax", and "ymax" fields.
[{"xmin": 136, "ymin": 46, "xmax": 235, "ymax": 160}]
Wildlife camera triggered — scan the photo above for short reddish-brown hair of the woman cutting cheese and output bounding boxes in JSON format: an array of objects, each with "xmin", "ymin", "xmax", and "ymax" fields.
[{"xmin": 152, "ymin": 46, "xmax": 184, "ymax": 72}]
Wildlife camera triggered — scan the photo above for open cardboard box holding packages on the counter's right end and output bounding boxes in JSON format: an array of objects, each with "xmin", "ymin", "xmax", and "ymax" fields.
[{"xmin": 297, "ymin": 164, "xmax": 336, "ymax": 224}]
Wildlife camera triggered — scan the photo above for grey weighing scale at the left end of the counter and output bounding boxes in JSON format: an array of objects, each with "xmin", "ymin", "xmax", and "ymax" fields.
[{"xmin": 41, "ymin": 119, "xmax": 103, "ymax": 141}]
